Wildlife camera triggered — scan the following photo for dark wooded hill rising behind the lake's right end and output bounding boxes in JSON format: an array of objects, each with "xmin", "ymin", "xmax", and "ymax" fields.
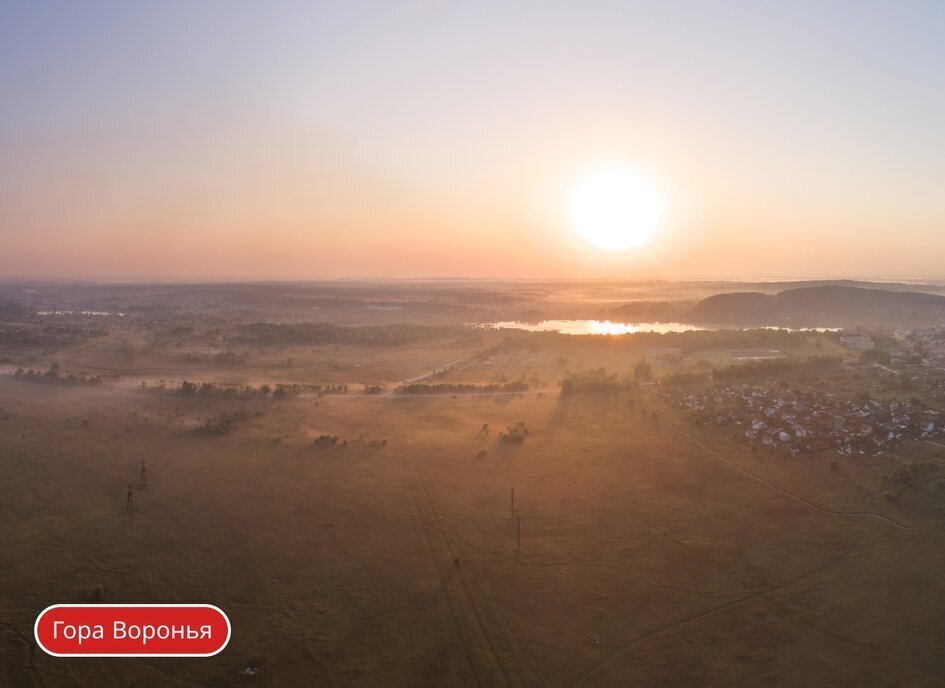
[{"xmin": 686, "ymin": 285, "xmax": 945, "ymax": 327}]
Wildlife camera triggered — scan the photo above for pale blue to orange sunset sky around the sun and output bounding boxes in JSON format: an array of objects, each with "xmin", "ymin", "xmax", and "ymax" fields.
[{"xmin": 0, "ymin": 0, "xmax": 945, "ymax": 280}]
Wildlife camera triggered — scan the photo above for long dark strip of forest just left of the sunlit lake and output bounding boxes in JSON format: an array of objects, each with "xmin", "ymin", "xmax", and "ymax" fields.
[{"xmin": 230, "ymin": 323, "xmax": 465, "ymax": 345}]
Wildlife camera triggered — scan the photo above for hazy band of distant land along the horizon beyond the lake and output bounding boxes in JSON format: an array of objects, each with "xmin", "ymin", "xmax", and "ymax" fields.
[{"xmin": 0, "ymin": 280, "xmax": 945, "ymax": 328}]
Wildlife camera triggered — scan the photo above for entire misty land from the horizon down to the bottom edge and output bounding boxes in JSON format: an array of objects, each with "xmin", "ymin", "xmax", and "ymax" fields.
[{"xmin": 0, "ymin": 281, "xmax": 945, "ymax": 686}]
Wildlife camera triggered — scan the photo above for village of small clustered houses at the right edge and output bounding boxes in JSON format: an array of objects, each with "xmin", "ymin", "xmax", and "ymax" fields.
[{"xmin": 660, "ymin": 328, "xmax": 945, "ymax": 457}]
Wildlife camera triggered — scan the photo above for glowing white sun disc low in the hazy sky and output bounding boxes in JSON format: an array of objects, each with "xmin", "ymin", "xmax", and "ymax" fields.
[{"xmin": 571, "ymin": 167, "xmax": 663, "ymax": 251}]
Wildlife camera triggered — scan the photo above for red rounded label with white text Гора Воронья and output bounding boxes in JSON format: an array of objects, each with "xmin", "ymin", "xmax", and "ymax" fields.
[{"xmin": 33, "ymin": 604, "xmax": 230, "ymax": 657}]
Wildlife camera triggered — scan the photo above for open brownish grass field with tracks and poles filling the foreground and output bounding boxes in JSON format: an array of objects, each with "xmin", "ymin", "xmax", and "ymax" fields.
[{"xmin": 0, "ymin": 324, "xmax": 945, "ymax": 688}]
